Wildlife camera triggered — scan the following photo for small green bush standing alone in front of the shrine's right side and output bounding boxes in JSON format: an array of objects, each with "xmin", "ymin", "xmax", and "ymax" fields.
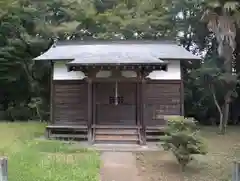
[{"xmin": 163, "ymin": 117, "xmax": 206, "ymax": 170}]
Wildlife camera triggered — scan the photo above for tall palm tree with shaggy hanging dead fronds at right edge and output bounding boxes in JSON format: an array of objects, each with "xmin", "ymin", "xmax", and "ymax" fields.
[{"xmin": 202, "ymin": 0, "xmax": 240, "ymax": 134}]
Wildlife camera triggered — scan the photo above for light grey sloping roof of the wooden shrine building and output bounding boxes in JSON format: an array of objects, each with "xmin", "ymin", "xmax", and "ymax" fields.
[{"xmin": 35, "ymin": 40, "xmax": 201, "ymax": 64}]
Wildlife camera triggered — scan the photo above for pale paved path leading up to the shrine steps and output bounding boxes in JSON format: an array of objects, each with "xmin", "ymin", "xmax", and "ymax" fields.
[{"xmin": 101, "ymin": 152, "xmax": 142, "ymax": 181}]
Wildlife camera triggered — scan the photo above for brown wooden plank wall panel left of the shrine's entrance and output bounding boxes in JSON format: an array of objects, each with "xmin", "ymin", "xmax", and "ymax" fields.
[{"xmin": 53, "ymin": 80, "xmax": 88, "ymax": 125}]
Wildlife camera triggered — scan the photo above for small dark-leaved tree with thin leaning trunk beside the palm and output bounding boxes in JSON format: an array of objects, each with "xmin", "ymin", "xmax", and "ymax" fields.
[{"xmin": 191, "ymin": 59, "xmax": 238, "ymax": 132}]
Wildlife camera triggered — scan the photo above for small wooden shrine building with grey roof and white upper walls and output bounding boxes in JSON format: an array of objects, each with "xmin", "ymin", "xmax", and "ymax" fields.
[{"xmin": 35, "ymin": 40, "xmax": 200, "ymax": 144}]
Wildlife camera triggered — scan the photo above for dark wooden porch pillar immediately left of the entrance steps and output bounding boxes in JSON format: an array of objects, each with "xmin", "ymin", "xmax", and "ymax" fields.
[{"xmin": 87, "ymin": 78, "xmax": 93, "ymax": 143}]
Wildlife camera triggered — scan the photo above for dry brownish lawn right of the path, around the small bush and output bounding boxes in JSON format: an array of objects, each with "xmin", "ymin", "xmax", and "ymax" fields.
[{"xmin": 137, "ymin": 127, "xmax": 240, "ymax": 181}]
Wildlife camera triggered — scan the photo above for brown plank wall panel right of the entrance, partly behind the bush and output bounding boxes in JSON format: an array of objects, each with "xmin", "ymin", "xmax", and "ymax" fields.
[{"xmin": 144, "ymin": 80, "xmax": 181, "ymax": 127}]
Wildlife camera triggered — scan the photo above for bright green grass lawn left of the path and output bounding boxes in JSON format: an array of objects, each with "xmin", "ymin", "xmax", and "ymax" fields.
[{"xmin": 0, "ymin": 123, "xmax": 100, "ymax": 181}]
